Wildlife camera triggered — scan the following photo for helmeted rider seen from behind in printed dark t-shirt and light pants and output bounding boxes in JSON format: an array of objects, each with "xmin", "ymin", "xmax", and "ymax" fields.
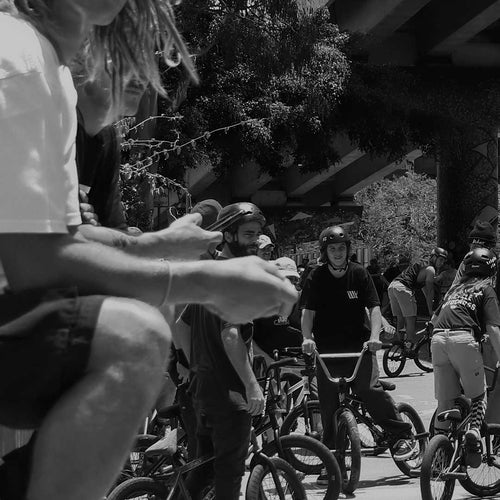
[{"xmin": 431, "ymin": 248, "xmax": 500, "ymax": 467}]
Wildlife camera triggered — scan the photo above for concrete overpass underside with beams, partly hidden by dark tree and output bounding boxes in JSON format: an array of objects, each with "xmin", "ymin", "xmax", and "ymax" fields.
[{"xmin": 186, "ymin": 0, "xmax": 500, "ymax": 206}]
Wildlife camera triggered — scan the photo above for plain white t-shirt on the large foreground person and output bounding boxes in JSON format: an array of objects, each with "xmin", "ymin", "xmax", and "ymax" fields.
[{"xmin": 0, "ymin": 13, "xmax": 81, "ymax": 233}]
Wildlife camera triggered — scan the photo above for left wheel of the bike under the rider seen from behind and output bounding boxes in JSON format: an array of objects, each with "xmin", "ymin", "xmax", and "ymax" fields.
[{"xmin": 420, "ymin": 434, "xmax": 455, "ymax": 500}]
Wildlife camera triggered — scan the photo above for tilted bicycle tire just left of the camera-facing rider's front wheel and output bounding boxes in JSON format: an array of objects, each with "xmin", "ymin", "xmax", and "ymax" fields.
[{"xmin": 264, "ymin": 435, "xmax": 342, "ymax": 500}]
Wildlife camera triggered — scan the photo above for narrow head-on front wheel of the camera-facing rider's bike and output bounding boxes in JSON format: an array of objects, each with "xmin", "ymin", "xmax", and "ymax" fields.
[{"xmin": 335, "ymin": 410, "xmax": 361, "ymax": 493}]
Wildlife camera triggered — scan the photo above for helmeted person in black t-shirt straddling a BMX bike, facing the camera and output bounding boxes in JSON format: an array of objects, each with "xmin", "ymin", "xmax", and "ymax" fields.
[{"xmin": 302, "ymin": 226, "xmax": 415, "ymax": 472}]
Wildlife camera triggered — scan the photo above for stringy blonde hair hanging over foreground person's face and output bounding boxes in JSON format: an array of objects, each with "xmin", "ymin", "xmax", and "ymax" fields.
[{"xmin": 81, "ymin": 0, "xmax": 198, "ymax": 119}]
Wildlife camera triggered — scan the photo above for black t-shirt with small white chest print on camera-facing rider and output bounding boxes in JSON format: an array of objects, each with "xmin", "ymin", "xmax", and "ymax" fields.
[{"xmin": 302, "ymin": 262, "xmax": 380, "ymax": 353}]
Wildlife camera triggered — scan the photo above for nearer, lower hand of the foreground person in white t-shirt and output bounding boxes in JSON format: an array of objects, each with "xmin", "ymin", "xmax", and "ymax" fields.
[{"xmin": 200, "ymin": 256, "xmax": 298, "ymax": 324}]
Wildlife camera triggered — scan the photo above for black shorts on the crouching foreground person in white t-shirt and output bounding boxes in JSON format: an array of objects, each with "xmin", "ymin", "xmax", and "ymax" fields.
[{"xmin": 0, "ymin": 288, "xmax": 106, "ymax": 429}]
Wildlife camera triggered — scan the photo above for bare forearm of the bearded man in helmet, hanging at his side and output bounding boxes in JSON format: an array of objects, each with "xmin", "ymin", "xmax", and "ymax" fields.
[{"xmin": 221, "ymin": 326, "xmax": 264, "ymax": 415}]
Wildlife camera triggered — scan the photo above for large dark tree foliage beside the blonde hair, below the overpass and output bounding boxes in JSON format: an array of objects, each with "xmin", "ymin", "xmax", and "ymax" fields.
[{"xmin": 155, "ymin": 0, "xmax": 349, "ymax": 177}]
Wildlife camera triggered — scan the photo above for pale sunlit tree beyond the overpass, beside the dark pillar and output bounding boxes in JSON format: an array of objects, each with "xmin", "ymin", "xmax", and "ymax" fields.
[{"xmin": 355, "ymin": 169, "xmax": 437, "ymax": 262}]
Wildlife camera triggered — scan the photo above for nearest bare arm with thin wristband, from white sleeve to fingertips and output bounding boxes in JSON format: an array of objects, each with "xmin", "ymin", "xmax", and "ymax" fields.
[{"xmin": 0, "ymin": 231, "xmax": 297, "ymax": 323}]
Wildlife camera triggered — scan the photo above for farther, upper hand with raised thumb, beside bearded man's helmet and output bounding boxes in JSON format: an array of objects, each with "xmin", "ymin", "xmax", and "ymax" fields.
[{"xmin": 157, "ymin": 213, "xmax": 222, "ymax": 260}]
